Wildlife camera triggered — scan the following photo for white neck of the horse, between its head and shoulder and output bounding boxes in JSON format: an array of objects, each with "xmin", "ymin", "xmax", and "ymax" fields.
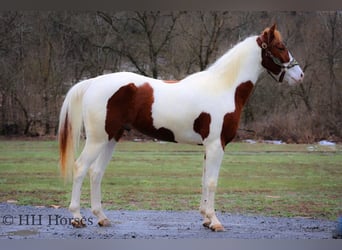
[{"xmin": 208, "ymin": 36, "xmax": 262, "ymax": 87}]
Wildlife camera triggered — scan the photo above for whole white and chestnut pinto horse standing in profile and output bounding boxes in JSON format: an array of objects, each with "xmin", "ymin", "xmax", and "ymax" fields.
[{"xmin": 58, "ymin": 24, "xmax": 304, "ymax": 231}]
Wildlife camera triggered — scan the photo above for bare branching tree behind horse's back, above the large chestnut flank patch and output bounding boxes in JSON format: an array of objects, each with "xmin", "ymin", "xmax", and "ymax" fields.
[{"xmin": 97, "ymin": 11, "xmax": 182, "ymax": 78}]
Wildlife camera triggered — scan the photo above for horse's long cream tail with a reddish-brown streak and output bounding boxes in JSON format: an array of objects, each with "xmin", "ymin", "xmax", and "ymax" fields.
[{"xmin": 58, "ymin": 80, "xmax": 91, "ymax": 180}]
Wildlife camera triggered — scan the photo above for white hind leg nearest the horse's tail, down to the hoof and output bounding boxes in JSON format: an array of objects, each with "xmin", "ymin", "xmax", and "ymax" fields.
[{"xmin": 69, "ymin": 138, "xmax": 107, "ymax": 227}]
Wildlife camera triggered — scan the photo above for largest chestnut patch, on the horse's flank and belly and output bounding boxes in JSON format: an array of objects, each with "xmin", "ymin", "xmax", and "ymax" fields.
[{"xmin": 105, "ymin": 83, "xmax": 176, "ymax": 142}]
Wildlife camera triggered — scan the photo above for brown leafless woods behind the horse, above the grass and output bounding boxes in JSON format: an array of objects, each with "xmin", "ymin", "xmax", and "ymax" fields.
[{"xmin": 0, "ymin": 11, "xmax": 342, "ymax": 143}]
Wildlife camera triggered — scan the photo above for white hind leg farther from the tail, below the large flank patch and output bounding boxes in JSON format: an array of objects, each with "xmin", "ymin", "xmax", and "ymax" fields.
[{"xmin": 89, "ymin": 140, "xmax": 116, "ymax": 226}]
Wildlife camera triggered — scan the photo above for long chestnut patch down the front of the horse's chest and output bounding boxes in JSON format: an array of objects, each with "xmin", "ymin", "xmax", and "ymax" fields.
[{"xmin": 221, "ymin": 81, "xmax": 253, "ymax": 148}]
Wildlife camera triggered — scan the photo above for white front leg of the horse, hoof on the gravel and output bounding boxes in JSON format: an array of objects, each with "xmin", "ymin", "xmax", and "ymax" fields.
[{"xmin": 200, "ymin": 141, "xmax": 224, "ymax": 232}]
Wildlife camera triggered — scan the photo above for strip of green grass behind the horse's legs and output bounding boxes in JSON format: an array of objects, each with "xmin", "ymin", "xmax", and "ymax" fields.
[{"xmin": 0, "ymin": 140, "xmax": 342, "ymax": 220}]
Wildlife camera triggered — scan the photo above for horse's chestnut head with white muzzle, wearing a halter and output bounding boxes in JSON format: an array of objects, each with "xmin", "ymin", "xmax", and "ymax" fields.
[{"xmin": 257, "ymin": 24, "xmax": 304, "ymax": 85}]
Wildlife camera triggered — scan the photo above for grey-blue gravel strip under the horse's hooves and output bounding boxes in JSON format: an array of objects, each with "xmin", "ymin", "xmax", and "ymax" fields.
[{"xmin": 0, "ymin": 203, "xmax": 337, "ymax": 239}]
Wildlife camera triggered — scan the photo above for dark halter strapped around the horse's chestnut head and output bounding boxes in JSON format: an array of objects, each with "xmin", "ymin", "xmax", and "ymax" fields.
[{"xmin": 257, "ymin": 37, "xmax": 298, "ymax": 82}]
